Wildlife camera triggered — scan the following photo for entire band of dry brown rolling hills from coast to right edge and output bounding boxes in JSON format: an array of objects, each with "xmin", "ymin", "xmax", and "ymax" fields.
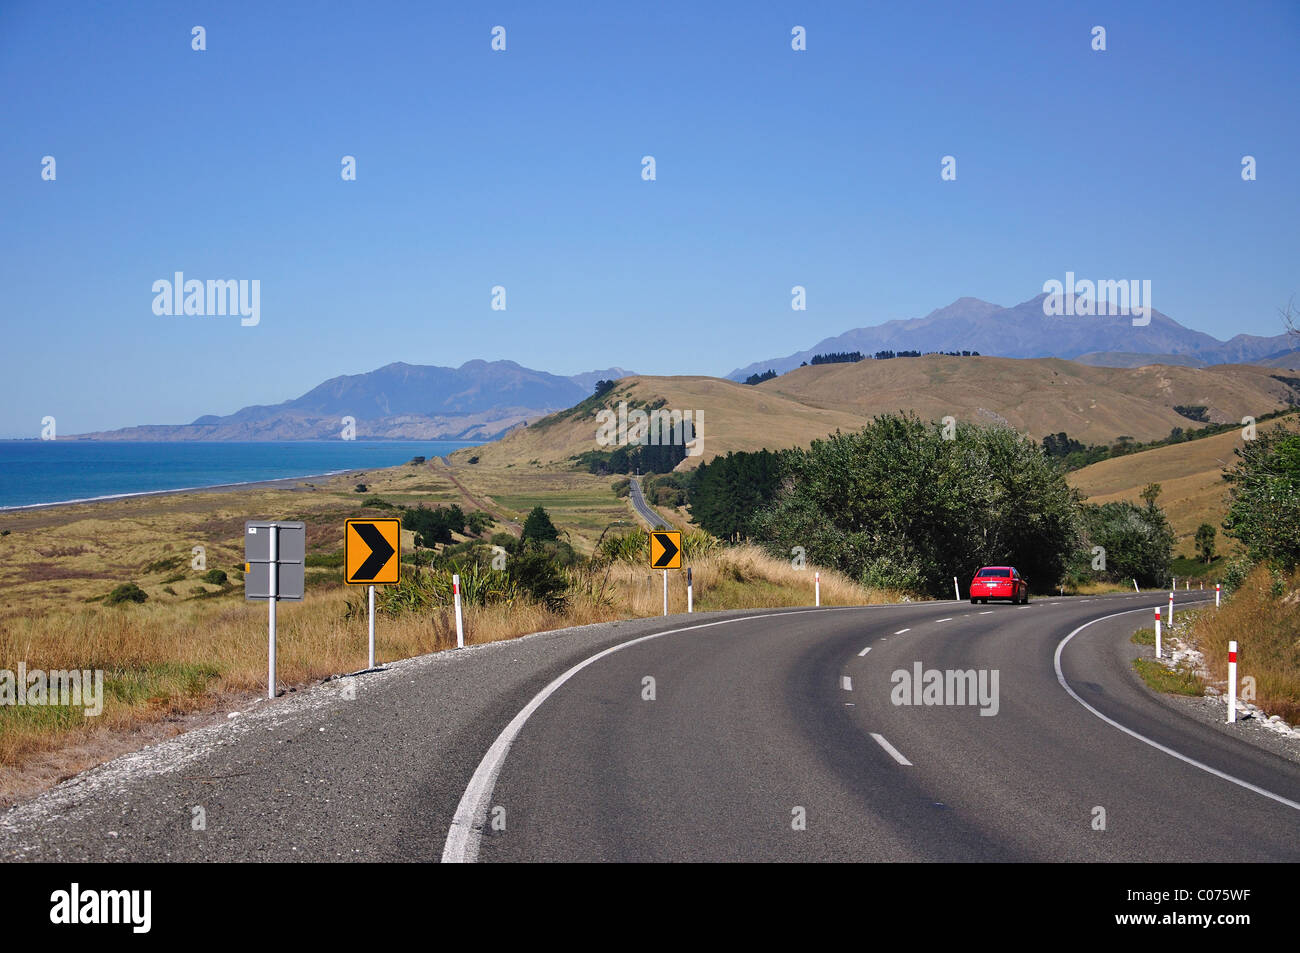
[{"xmin": 455, "ymin": 356, "xmax": 1294, "ymax": 467}]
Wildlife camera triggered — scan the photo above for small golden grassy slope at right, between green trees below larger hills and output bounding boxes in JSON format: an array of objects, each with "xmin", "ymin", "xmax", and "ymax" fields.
[{"xmin": 1069, "ymin": 413, "xmax": 1300, "ymax": 555}]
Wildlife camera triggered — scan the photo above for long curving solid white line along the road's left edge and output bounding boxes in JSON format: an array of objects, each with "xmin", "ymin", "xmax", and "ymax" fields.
[{"xmin": 442, "ymin": 606, "xmax": 863, "ymax": 863}]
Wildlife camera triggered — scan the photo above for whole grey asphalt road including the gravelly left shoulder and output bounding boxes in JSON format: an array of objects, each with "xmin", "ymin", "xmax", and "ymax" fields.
[{"xmin": 0, "ymin": 593, "xmax": 1300, "ymax": 861}]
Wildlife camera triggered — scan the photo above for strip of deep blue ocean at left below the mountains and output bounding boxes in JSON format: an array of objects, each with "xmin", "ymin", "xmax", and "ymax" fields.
[{"xmin": 0, "ymin": 439, "xmax": 481, "ymax": 508}]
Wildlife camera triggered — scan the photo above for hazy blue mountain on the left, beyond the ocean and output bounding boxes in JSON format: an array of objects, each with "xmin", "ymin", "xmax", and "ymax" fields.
[{"xmin": 81, "ymin": 360, "xmax": 627, "ymax": 441}]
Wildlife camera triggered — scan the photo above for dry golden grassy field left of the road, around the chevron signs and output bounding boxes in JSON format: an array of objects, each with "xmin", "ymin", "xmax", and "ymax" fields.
[{"xmin": 0, "ymin": 462, "xmax": 896, "ymax": 802}]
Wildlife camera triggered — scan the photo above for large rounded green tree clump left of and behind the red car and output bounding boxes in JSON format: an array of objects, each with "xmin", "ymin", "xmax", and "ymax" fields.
[{"xmin": 750, "ymin": 415, "xmax": 1079, "ymax": 595}]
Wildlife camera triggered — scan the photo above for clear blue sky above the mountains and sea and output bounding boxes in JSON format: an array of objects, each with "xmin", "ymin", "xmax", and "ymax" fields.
[{"xmin": 0, "ymin": 0, "xmax": 1300, "ymax": 437}]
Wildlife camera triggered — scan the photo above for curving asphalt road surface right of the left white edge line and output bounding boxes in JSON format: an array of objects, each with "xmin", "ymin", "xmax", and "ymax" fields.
[{"xmin": 445, "ymin": 595, "xmax": 1300, "ymax": 861}]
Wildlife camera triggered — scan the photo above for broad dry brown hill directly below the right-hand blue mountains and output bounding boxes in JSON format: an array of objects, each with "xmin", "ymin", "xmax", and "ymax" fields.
[{"xmin": 758, "ymin": 355, "xmax": 1300, "ymax": 443}]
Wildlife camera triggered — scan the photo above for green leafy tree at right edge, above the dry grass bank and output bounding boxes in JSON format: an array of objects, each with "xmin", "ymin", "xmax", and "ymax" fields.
[{"xmin": 1223, "ymin": 426, "xmax": 1300, "ymax": 569}]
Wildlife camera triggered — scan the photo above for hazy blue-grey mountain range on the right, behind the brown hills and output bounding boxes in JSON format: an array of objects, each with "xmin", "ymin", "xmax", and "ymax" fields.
[{"xmin": 728, "ymin": 295, "xmax": 1290, "ymax": 381}]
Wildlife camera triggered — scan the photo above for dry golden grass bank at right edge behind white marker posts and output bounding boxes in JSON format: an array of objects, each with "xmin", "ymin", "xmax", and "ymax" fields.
[{"xmin": 1191, "ymin": 567, "xmax": 1300, "ymax": 724}]
